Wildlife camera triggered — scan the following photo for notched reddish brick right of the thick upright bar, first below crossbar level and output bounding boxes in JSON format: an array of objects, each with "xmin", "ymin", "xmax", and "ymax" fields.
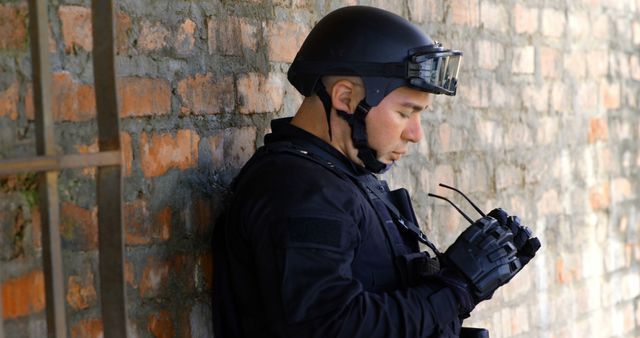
[{"xmin": 124, "ymin": 200, "xmax": 171, "ymax": 245}]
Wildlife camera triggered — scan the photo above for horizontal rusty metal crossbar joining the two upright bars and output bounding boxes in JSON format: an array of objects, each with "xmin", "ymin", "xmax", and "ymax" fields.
[{"xmin": 0, "ymin": 151, "xmax": 120, "ymax": 176}]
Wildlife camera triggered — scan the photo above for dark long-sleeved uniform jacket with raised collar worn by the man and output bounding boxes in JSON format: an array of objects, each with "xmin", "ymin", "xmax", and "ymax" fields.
[{"xmin": 220, "ymin": 119, "xmax": 460, "ymax": 338}]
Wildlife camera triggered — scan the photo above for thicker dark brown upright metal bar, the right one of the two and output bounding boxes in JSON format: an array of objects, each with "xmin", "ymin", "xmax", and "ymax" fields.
[{"xmin": 91, "ymin": 0, "xmax": 128, "ymax": 338}]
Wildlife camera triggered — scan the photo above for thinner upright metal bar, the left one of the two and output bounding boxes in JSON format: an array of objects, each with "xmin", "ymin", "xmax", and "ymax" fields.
[{"xmin": 29, "ymin": 0, "xmax": 67, "ymax": 338}]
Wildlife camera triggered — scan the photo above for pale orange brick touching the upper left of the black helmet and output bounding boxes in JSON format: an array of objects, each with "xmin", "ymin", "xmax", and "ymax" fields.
[{"xmin": 267, "ymin": 21, "xmax": 308, "ymax": 62}]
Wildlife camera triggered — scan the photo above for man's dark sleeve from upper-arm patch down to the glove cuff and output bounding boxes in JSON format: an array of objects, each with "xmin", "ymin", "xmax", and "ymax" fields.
[{"xmin": 279, "ymin": 212, "xmax": 460, "ymax": 338}]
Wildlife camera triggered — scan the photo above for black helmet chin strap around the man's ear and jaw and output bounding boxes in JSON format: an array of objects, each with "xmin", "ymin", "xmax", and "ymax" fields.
[{"xmin": 316, "ymin": 82, "xmax": 393, "ymax": 174}]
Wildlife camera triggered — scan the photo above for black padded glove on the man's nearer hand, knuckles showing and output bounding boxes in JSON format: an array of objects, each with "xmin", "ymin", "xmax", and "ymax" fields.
[{"xmin": 439, "ymin": 216, "xmax": 522, "ymax": 315}]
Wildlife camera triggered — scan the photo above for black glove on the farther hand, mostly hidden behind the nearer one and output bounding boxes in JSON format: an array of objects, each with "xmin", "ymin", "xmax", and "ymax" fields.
[{"xmin": 489, "ymin": 208, "xmax": 541, "ymax": 267}]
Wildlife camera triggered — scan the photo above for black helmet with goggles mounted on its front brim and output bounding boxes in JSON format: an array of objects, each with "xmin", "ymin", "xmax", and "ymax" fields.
[{"xmin": 287, "ymin": 6, "xmax": 462, "ymax": 107}]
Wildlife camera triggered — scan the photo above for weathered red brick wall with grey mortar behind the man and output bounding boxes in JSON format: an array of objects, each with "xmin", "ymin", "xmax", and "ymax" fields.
[{"xmin": 0, "ymin": 0, "xmax": 640, "ymax": 337}]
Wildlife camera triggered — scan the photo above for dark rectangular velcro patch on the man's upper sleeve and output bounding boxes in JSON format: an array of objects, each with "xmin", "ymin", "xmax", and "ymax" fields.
[{"xmin": 287, "ymin": 217, "xmax": 343, "ymax": 248}]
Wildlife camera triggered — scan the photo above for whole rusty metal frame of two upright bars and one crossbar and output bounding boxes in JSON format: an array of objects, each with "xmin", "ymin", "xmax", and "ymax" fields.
[{"xmin": 0, "ymin": 0, "xmax": 128, "ymax": 338}]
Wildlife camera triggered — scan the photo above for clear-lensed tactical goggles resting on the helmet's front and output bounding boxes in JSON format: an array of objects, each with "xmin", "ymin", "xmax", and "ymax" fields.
[{"xmin": 406, "ymin": 42, "xmax": 462, "ymax": 96}]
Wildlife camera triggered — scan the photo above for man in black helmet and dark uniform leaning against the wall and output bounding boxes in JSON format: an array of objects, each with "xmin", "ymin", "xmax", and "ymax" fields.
[{"xmin": 214, "ymin": 6, "xmax": 539, "ymax": 338}]
